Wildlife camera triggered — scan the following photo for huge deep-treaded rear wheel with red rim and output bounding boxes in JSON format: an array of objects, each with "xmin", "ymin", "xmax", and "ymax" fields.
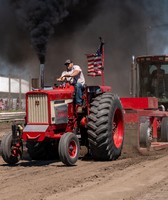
[{"xmin": 88, "ymin": 93, "xmax": 124, "ymax": 161}]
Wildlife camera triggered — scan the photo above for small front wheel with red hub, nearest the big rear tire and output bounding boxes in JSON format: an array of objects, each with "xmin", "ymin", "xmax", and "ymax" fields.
[{"xmin": 58, "ymin": 132, "xmax": 80, "ymax": 166}]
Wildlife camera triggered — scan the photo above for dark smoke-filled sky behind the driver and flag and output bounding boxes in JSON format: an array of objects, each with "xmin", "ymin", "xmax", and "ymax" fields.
[{"xmin": 0, "ymin": 0, "xmax": 168, "ymax": 96}]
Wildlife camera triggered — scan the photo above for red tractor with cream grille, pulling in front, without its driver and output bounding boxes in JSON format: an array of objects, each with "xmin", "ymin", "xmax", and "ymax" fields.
[{"xmin": 1, "ymin": 65, "xmax": 124, "ymax": 166}]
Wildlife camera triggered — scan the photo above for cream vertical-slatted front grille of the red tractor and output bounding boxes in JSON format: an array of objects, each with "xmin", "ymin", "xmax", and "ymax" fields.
[{"xmin": 28, "ymin": 94, "xmax": 48, "ymax": 123}]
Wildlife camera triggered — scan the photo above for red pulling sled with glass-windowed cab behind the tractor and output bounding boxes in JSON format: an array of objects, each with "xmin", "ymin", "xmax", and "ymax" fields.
[{"xmin": 120, "ymin": 55, "xmax": 168, "ymax": 152}]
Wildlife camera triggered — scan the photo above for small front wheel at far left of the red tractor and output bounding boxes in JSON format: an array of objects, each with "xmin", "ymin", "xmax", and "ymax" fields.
[{"xmin": 1, "ymin": 133, "xmax": 23, "ymax": 165}]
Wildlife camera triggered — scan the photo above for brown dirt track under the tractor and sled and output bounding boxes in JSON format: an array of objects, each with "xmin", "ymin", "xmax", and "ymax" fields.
[{"xmin": 0, "ymin": 122, "xmax": 168, "ymax": 200}]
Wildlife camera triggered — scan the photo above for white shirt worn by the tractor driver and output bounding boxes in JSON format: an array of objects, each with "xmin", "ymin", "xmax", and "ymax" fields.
[{"xmin": 61, "ymin": 65, "xmax": 85, "ymax": 85}]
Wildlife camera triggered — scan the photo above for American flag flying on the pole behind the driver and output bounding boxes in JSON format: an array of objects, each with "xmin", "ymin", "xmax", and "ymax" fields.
[{"xmin": 86, "ymin": 43, "xmax": 103, "ymax": 76}]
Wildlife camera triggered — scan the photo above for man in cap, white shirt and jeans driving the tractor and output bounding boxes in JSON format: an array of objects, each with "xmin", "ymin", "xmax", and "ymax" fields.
[{"xmin": 57, "ymin": 59, "xmax": 85, "ymax": 110}]
